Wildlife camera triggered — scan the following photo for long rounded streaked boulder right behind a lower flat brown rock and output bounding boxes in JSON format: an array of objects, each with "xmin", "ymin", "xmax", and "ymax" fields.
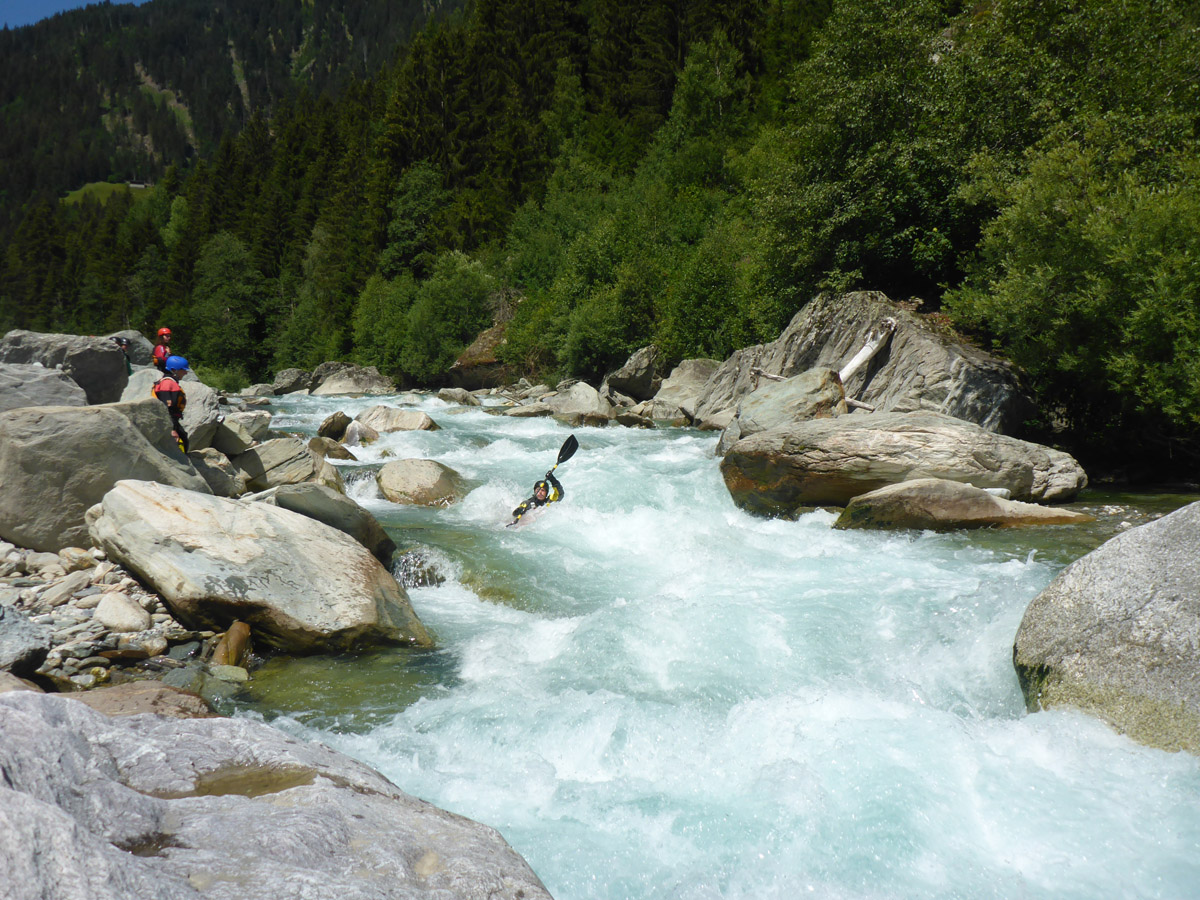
[{"xmin": 721, "ymin": 413, "xmax": 1087, "ymax": 516}]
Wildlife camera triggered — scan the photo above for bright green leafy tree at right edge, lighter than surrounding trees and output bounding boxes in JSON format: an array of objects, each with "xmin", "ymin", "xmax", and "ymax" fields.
[{"xmin": 948, "ymin": 121, "xmax": 1200, "ymax": 451}]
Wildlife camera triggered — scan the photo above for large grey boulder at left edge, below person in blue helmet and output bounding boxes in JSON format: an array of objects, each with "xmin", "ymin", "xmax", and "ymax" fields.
[{"xmin": 0, "ymin": 400, "xmax": 209, "ymax": 552}]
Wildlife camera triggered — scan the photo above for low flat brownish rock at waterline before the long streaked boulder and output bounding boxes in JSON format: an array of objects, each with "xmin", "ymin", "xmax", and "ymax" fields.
[{"xmin": 834, "ymin": 478, "xmax": 1093, "ymax": 532}]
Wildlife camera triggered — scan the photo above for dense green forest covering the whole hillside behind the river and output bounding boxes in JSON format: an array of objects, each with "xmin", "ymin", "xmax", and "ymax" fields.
[{"xmin": 0, "ymin": 0, "xmax": 1200, "ymax": 480}]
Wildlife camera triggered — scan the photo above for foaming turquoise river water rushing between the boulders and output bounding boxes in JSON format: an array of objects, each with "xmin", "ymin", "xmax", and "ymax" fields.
[{"xmin": 240, "ymin": 397, "xmax": 1200, "ymax": 900}]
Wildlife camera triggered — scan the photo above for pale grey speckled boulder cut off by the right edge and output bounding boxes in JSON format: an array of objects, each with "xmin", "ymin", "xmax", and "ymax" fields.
[{"xmin": 1013, "ymin": 503, "xmax": 1200, "ymax": 754}]
